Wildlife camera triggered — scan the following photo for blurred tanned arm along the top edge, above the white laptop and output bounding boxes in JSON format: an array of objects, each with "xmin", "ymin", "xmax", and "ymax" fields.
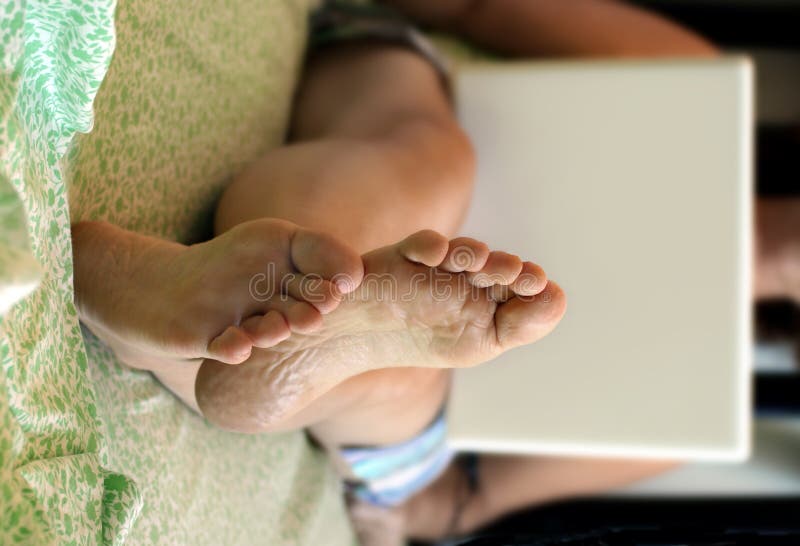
[{"xmin": 382, "ymin": 0, "xmax": 716, "ymax": 58}]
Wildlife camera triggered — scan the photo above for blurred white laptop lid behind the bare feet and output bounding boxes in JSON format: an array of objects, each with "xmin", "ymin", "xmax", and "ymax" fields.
[{"xmin": 448, "ymin": 58, "xmax": 753, "ymax": 460}]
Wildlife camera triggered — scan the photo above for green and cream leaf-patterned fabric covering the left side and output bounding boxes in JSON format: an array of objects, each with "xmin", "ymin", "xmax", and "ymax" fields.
[{"xmin": 0, "ymin": 0, "xmax": 354, "ymax": 545}]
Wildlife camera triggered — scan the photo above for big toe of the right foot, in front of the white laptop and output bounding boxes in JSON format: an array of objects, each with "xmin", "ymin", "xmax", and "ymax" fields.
[{"xmin": 495, "ymin": 281, "xmax": 567, "ymax": 349}]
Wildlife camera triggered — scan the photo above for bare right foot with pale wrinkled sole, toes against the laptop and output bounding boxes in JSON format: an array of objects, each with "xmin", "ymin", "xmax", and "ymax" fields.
[{"xmin": 195, "ymin": 231, "xmax": 565, "ymax": 432}]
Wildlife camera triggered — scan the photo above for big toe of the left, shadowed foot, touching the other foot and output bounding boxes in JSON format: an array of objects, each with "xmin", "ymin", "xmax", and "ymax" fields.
[{"xmin": 291, "ymin": 229, "xmax": 364, "ymax": 294}]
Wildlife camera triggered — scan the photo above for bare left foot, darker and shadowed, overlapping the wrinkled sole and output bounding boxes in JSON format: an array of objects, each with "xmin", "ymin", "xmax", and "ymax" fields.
[{"xmin": 73, "ymin": 219, "xmax": 363, "ymax": 372}]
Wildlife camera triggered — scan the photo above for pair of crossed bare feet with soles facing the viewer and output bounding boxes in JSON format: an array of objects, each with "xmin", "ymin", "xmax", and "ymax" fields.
[{"xmin": 81, "ymin": 215, "xmax": 565, "ymax": 432}]
